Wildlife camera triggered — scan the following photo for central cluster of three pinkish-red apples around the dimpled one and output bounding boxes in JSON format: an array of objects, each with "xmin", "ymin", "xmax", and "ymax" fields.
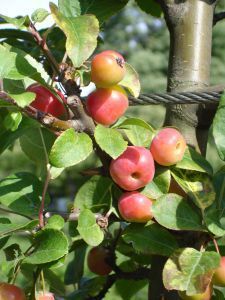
[{"xmin": 110, "ymin": 128, "xmax": 186, "ymax": 223}]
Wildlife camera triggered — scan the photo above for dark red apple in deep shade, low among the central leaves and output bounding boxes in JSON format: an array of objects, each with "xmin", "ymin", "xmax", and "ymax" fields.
[{"xmin": 87, "ymin": 246, "xmax": 112, "ymax": 276}]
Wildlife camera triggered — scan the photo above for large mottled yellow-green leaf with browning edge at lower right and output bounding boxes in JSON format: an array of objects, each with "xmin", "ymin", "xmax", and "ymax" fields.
[{"xmin": 163, "ymin": 248, "xmax": 220, "ymax": 296}]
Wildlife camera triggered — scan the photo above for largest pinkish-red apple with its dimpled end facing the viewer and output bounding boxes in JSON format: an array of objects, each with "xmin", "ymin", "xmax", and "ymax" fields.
[{"xmin": 109, "ymin": 146, "xmax": 155, "ymax": 191}]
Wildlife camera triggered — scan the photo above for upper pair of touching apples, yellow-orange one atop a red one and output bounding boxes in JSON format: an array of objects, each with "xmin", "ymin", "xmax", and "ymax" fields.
[{"xmin": 86, "ymin": 50, "xmax": 129, "ymax": 125}]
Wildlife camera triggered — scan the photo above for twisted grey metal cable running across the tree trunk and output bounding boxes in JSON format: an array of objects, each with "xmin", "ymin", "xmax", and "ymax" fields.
[{"xmin": 129, "ymin": 91, "xmax": 223, "ymax": 105}]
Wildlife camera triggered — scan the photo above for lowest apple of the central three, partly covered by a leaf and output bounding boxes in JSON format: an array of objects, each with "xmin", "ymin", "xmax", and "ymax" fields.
[{"xmin": 118, "ymin": 191, "xmax": 153, "ymax": 223}]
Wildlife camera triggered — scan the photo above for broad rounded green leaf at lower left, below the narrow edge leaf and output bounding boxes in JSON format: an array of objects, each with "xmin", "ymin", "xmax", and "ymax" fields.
[{"xmin": 24, "ymin": 228, "xmax": 68, "ymax": 265}]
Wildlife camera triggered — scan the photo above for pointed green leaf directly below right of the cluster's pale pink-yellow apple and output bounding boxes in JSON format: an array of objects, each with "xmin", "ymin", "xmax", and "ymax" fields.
[{"xmin": 175, "ymin": 147, "xmax": 213, "ymax": 175}]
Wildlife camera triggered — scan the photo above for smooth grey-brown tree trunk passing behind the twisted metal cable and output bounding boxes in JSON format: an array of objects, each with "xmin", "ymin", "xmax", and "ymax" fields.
[{"xmin": 149, "ymin": 0, "xmax": 215, "ymax": 300}]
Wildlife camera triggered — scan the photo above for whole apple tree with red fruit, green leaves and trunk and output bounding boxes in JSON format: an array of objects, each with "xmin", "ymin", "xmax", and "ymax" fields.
[{"xmin": 0, "ymin": 0, "xmax": 225, "ymax": 300}]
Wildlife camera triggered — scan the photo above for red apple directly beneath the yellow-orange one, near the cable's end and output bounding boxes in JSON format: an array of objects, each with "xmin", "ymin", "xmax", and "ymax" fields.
[{"xmin": 87, "ymin": 86, "xmax": 129, "ymax": 125}]
